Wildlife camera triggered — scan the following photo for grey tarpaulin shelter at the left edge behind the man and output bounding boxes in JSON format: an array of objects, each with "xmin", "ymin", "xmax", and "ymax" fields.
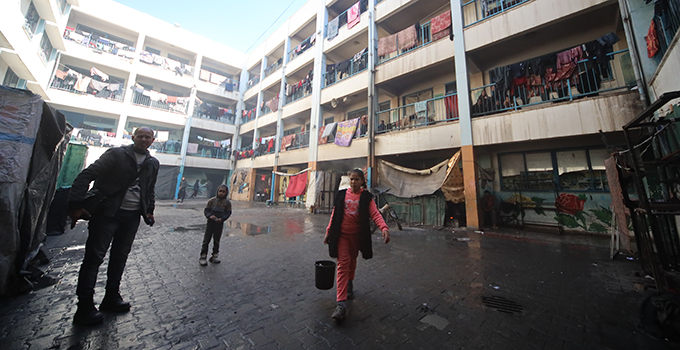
[{"xmin": 0, "ymin": 86, "xmax": 72, "ymax": 295}]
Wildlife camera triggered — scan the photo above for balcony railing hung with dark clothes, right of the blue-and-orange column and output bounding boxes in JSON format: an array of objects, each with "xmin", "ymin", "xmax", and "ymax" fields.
[{"xmin": 470, "ymin": 49, "xmax": 636, "ymax": 116}]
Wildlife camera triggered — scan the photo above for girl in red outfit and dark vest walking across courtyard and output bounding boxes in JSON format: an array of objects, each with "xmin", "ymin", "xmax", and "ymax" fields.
[{"xmin": 323, "ymin": 169, "xmax": 390, "ymax": 321}]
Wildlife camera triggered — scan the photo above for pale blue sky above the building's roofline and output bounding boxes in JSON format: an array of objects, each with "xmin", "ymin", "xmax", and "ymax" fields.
[{"xmin": 115, "ymin": 0, "xmax": 308, "ymax": 52}]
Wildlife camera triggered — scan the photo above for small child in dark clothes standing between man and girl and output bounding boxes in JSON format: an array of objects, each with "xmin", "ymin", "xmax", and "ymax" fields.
[{"xmin": 198, "ymin": 185, "xmax": 231, "ymax": 266}]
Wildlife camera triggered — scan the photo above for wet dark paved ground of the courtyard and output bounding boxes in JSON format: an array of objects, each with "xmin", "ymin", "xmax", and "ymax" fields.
[{"xmin": 0, "ymin": 200, "xmax": 644, "ymax": 350}]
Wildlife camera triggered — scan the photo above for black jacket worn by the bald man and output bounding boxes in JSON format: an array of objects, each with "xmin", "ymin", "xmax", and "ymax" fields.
[{"xmin": 68, "ymin": 145, "xmax": 160, "ymax": 217}]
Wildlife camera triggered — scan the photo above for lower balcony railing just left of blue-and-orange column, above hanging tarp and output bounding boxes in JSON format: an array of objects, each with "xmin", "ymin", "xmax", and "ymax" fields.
[{"xmin": 376, "ymin": 93, "xmax": 458, "ymax": 133}]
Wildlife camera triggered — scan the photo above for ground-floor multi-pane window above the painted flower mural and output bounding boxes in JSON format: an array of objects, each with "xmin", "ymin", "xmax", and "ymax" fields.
[{"xmin": 499, "ymin": 149, "xmax": 609, "ymax": 191}]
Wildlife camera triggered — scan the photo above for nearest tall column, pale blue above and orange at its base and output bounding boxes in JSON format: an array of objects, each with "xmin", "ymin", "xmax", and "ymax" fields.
[{"xmin": 451, "ymin": 0, "xmax": 479, "ymax": 228}]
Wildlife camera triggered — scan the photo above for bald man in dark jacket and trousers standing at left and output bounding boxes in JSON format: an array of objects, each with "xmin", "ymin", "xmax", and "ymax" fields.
[{"xmin": 69, "ymin": 127, "xmax": 159, "ymax": 325}]
